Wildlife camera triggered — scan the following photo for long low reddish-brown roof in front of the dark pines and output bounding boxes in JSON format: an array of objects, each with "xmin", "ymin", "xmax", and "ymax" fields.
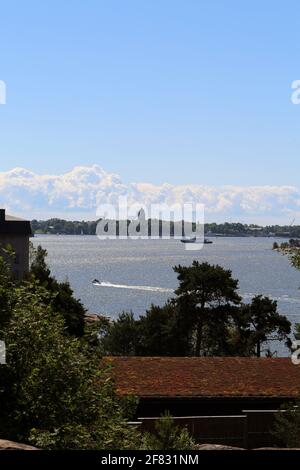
[{"xmin": 105, "ymin": 357, "xmax": 300, "ymax": 398}]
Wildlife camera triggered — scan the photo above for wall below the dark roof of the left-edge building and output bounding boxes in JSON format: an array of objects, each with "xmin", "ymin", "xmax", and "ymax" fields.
[{"xmin": 0, "ymin": 234, "xmax": 29, "ymax": 279}]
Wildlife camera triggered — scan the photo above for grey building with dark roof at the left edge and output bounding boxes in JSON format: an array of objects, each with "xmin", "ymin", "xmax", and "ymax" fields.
[{"xmin": 0, "ymin": 209, "xmax": 32, "ymax": 279}]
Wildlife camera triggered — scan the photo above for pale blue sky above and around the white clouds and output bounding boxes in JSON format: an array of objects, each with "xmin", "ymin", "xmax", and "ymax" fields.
[{"xmin": 0, "ymin": 0, "xmax": 300, "ymax": 224}]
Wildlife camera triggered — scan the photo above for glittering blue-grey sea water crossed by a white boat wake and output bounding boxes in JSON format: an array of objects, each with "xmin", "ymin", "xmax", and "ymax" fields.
[{"xmin": 33, "ymin": 235, "xmax": 300, "ymax": 323}]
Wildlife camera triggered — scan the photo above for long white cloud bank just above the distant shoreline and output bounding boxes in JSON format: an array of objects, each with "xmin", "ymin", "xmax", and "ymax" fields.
[{"xmin": 0, "ymin": 165, "xmax": 300, "ymax": 224}]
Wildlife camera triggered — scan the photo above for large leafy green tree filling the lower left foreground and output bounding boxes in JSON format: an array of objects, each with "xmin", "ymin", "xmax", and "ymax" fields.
[{"xmin": 0, "ymin": 283, "xmax": 138, "ymax": 449}]
